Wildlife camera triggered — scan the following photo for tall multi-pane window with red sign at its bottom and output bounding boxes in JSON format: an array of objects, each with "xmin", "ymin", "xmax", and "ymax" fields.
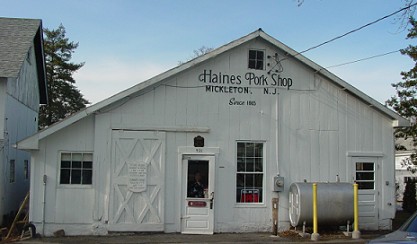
[{"xmin": 236, "ymin": 142, "xmax": 264, "ymax": 203}]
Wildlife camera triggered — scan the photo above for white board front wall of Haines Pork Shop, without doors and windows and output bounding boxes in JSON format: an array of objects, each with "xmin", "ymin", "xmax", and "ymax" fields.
[{"xmin": 31, "ymin": 37, "xmax": 395, "ymax": 235}]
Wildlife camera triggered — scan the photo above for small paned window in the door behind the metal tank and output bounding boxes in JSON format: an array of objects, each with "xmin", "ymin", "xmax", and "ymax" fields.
[{"xmin": 356, "ymin": 162, "xmax": 375, "ymax": 190}]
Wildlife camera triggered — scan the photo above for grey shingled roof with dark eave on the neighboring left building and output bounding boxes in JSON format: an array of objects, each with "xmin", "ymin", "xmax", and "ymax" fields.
[{"xmin": 0, "ymin": 18, "xmax": 48, "ymax": 104}]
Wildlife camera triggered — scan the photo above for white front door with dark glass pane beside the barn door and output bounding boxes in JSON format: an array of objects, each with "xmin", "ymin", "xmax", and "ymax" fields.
[{"xmin": 181, "ymin": 155, "xmax": 215, "ymax": 234}]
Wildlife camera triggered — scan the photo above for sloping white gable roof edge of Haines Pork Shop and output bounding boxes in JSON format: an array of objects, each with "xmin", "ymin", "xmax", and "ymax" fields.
[{"xmin": 16, "ymin": 29, "xmax": 409, "ymax": 150}]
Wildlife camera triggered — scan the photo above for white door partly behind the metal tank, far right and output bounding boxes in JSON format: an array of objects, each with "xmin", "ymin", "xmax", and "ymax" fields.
[{"xmin": 353, "ymin": 157, "xmax": 379, "ymax": 230}]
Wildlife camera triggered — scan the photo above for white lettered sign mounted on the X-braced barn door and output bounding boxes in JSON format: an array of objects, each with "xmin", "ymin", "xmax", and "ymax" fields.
[{"xmin": 127, "ymin": 162, "xmax": 148, "ymax": 192}]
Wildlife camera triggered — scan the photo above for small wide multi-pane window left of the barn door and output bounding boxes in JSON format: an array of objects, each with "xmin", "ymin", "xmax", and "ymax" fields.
[{"xmin": 59, "ymin": 152, "xmax": 93, "ymax": 185}]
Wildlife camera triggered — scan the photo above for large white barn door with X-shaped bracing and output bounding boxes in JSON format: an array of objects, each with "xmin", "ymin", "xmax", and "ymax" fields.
[{"xmin": 108, "ymin": 130, "xmax": 165, "ymax": 231}]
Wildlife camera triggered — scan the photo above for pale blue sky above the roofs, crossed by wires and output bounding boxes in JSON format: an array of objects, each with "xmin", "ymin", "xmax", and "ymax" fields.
[{"xmin": 0, "ymin": 0, "xmax": 415, "ymax": 103}]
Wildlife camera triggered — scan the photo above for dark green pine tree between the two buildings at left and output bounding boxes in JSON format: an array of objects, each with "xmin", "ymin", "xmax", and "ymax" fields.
[{"xmin": 39, "ymin": 24, "xmax": 89, "ymax": 129}]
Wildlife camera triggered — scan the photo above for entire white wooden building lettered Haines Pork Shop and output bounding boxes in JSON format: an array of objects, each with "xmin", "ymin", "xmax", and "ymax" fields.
[{"xmin": 18, "ymin": 29, "xmax": 408, "ymax": 235}]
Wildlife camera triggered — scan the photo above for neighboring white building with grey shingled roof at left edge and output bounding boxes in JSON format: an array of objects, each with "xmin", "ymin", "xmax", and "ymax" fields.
[{"xmin": 0, "ymin": 18, "xmax": 47, "ymax": 225}]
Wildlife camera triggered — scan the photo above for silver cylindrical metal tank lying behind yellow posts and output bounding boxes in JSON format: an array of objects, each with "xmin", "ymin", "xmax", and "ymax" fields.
[{"xmin": 289, "ymin": 183, "xmax": 353, "ymax": 227}]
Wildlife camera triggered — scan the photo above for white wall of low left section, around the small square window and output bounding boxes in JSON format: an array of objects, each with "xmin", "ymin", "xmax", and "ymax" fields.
[{"xmin": 29, "ymin": 117, "xmax": 94, "ymax": 235}]
